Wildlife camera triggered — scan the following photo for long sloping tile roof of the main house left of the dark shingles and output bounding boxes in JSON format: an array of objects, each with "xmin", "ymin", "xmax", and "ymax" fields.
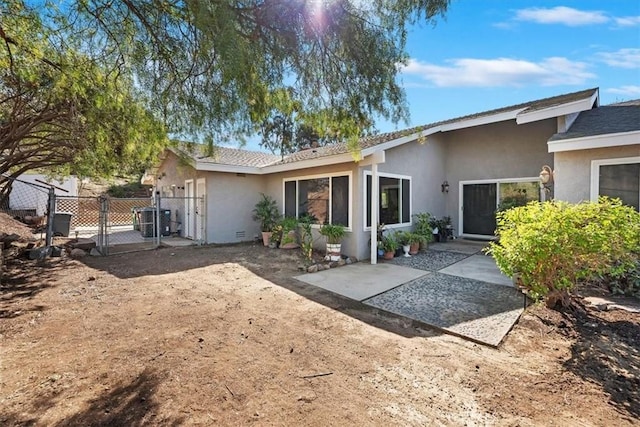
[{"xmin": 176, "ymin": 88, "xmax": 598, "ymax": 168}]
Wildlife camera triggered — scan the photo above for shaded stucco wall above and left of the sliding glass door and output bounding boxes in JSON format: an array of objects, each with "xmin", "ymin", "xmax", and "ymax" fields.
[{"xmin": 443, "ymin": 119, "xmax": 556, "ymax": 234}]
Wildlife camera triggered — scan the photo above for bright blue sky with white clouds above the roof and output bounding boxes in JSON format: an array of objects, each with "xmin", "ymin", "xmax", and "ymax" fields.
[{"xmin": 245, "ymin": 0, "xmax": 640, "ymax": 151}]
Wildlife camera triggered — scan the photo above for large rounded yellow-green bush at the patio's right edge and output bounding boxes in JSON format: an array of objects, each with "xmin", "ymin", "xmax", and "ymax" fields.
[{"xmin": 488, "ymin": 198, "xmax": 640, "ymax": 307}]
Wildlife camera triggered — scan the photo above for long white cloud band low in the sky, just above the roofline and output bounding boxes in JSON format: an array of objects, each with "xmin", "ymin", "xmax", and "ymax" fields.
[{"xmin": 402, "ymin": 57, "xmax": 595, "ymax": 87}]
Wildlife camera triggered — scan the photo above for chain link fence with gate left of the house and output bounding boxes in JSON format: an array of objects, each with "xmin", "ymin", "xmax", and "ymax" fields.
[{"xmin": 0, "ymin": 175, "xmax": 206, "ymax": 255}]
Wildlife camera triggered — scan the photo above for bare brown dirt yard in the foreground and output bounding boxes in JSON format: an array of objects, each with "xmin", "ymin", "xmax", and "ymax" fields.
[{"xmin": 0, "ymin": 245, "xmax": 640, "ymax": 426}]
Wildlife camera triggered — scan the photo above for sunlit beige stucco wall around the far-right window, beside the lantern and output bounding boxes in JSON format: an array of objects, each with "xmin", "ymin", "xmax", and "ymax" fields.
[{"xmin": 554, "ymin": 142, "xmax": 640, "ymax": 203}]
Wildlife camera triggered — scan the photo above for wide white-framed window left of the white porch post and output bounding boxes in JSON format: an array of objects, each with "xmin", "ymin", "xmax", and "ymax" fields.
[{"xmin": 284, "ymin": 175, "xmax": 351, "ymax": 227}]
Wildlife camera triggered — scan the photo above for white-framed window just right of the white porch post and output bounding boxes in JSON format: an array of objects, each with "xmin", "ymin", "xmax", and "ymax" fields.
[{"xmin": 365, "ymin": 172, "xmax": 411, "ymax": 227}]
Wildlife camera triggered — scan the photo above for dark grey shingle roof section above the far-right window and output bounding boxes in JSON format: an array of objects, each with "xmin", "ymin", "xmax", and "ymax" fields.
[{"xmin": 549, "ymin": 100, "xmax": 640, "ymax": 141}]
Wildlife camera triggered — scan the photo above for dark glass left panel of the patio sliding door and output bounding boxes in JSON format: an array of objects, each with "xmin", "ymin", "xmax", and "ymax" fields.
[{"xmin": 462, "ymin": 183, "xmax": 498, "ymax": 236}]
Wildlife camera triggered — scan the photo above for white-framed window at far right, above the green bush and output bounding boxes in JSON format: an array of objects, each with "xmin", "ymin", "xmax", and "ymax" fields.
[{"xmin": 591, "ymin": 157, "xmax": 640, "ymax": 210}]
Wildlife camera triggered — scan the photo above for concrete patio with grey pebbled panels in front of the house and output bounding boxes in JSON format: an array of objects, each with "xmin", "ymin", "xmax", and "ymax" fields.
[{"xmin": 296, "ymin": 240, "xmax": 525, "ymax": 346}]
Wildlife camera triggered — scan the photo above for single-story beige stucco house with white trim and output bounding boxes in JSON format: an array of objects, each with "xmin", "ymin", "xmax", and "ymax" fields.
[{"xmin": 146, "ymin": 88, "xmax": 640, "ymax": 262}]
